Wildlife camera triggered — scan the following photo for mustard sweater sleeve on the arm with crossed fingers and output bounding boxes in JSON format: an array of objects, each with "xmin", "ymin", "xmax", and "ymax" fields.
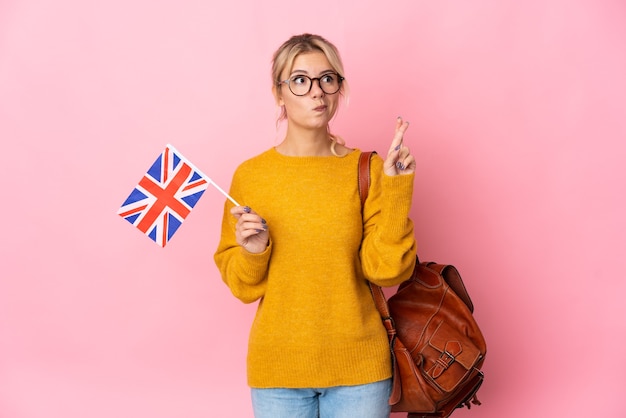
[{"xmin": 361, "ymin": 155, "xmax": 417, "ymax": 286}]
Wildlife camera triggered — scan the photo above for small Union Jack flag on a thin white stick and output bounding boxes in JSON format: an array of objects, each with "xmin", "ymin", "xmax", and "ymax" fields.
[{"xmin": 117, "ymin": 144, "xmax": 211, "ymax": 247}]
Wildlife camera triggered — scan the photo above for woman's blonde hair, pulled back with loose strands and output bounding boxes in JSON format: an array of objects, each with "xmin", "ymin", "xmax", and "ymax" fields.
[{"xmin": 272, "ymin": 33, "xmax": 349, "ymax": 153}]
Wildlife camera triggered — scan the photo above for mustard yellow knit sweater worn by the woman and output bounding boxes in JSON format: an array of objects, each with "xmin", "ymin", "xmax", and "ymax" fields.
[{"xmin": 215, "ymin": 148, "xmax": 416, "ymax": 388}]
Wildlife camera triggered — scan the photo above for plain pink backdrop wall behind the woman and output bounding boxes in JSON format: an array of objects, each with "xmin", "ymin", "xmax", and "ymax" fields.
[{"xmin": 0, "ymin": 0, "xmax": 626, "ymax": 418}]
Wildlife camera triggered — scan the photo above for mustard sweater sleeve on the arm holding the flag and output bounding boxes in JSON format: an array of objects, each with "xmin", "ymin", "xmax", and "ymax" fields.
[{"xmin": 213, "ymin": 168, "xmax": 272, "ymax": 303}]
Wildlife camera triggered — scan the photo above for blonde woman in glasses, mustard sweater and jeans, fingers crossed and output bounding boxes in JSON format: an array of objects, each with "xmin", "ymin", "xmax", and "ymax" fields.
[{"xmin": 215, "ymin": 34, "xmax": 416, "ymax": 418}]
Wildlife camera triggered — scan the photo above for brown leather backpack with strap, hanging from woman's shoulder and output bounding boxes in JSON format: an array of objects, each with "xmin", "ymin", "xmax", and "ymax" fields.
[{"xmin": 359, "ymin": 152, "xmax": 487, "ymax": 418}]
